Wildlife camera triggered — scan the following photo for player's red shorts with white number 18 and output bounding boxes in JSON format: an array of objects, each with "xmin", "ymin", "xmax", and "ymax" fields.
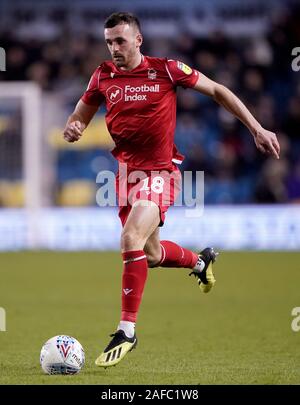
[{"xmin": 116, "ymin": 163, "xmax": 181, "ymax": 226}]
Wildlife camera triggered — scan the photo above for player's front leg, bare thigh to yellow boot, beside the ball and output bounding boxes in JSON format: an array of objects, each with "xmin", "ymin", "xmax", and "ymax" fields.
[{"xmin": 96, "ymin": 201, "xmax": 160, "ymax": 367}]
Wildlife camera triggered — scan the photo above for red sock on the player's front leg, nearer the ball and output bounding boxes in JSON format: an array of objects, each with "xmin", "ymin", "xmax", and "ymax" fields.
[{"xmin": 121, "ymin": 250, "xmax": 148, "ymax": 322}]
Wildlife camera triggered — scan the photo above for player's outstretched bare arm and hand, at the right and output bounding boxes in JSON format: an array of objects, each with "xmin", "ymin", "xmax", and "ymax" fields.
[{"xmin": 194, "ymin": 73, "xmax": 280, "ymax": 159}]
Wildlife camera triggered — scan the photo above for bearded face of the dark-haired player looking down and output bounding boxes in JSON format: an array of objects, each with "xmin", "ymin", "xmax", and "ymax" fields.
[{"xmin": 104, "ymin": 24, "xmax": 142, "ymax": 68}]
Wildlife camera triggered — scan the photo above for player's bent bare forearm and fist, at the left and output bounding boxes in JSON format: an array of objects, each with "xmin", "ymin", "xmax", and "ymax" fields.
[{"xmin": 64, "ymin": 100, "xmax": 98, "ymax": 142}]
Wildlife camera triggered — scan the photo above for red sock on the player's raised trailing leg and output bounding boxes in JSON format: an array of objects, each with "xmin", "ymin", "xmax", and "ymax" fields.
[{"xmin": 157, "ymin": 240, "xmax": 198, "ymax": 269}]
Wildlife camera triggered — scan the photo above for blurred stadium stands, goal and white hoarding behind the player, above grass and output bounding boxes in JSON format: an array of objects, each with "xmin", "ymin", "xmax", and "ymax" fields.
[{"xmin": 0, "ymin": 0, "xmax": 300, "ymax": 250}]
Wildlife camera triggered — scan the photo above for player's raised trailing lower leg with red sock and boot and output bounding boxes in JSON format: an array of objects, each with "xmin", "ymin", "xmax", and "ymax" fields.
[{"xmin": 144, "ymin": 228, "xmax": 217, "ymax": 293}]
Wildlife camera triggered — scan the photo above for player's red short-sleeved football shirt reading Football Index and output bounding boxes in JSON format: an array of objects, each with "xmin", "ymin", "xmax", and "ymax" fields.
[{"xmin": 81, "ymin": 56, "xmax": 199, "ymax": 169}]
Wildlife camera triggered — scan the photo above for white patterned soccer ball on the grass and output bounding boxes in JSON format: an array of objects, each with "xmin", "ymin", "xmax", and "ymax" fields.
[{"xmin": 40, "ymin": 335, "xmax": 85, "ymax": 374}]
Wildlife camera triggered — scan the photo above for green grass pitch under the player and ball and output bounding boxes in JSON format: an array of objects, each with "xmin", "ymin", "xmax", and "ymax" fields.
[{"xmin": 0, "ymin": 252, "xmax": 300, "ymax": 385}]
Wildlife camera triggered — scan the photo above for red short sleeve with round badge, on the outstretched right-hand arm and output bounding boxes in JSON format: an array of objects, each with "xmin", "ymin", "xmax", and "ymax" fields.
[{"xmin": 166, "ymin": 59, "xmax": 199, "ymax": 87}]
